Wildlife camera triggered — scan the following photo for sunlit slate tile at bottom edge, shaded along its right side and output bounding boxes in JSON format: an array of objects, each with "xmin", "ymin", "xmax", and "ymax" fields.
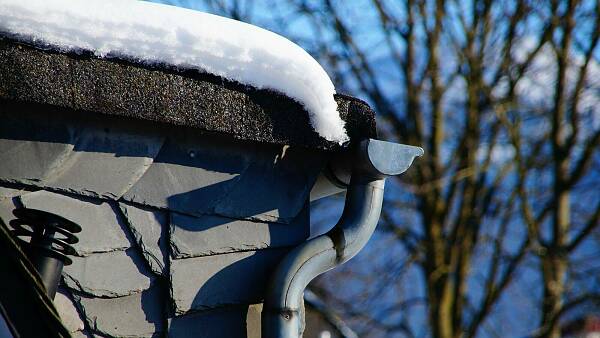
[{"xmin": 74, "ymin": 283, "xmax": 166, "ymax": 337}]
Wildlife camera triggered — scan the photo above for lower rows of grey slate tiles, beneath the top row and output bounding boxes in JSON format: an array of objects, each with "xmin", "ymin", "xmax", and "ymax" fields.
[{"xmin": 2, "ymin": 177, "xmax": 309, "ymax": 337}]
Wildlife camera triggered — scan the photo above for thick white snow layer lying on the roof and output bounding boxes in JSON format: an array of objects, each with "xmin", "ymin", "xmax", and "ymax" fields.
[{"xmin": 0, "ymin": 0, "xmax": 348, "ymax": 144}]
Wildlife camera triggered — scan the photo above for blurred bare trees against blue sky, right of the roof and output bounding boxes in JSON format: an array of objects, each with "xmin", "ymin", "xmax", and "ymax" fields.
[{"xmin": 169, "ymin": 0, "xmax": 600, "ymax": 338}]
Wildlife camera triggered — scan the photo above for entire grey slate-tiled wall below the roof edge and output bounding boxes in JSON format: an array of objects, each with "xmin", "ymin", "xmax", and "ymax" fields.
[{"xmin": 0, "ymin": 105, "xmax": 327, "ymax": 337}]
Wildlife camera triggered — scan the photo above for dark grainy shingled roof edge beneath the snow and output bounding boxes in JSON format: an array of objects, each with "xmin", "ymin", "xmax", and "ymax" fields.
[{"xmin": 0, "ymin": 36, "xmax": 376, "ymax": 150}]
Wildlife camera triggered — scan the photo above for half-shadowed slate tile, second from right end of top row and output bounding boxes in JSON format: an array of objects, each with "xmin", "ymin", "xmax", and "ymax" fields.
[{"xmin": 123, "ymin": 134, "xmax": 254, "ymax": 218}]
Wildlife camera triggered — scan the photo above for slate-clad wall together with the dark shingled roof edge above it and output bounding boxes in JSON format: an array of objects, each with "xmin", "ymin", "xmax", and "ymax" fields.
[{"xmin": 0, "ymin": 29, "xmax": 375, "ymax": 338}]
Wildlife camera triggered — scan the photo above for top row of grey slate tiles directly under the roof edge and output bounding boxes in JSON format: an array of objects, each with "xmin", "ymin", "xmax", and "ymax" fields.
[{"xmin": 0, "ymin": 104, "xmax": 327, "ymax": 223}]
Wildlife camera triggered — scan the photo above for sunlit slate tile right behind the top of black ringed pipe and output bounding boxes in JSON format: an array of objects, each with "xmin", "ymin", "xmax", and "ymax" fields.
[{"xmin": 19, "ymin": 190, "xmax": 130, "ymax": 255}]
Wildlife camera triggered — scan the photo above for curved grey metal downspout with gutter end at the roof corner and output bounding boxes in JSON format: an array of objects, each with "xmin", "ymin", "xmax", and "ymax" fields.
[{"xmin": 262, "ymin": 139, "xmax": 423, "ymax": 338}]
